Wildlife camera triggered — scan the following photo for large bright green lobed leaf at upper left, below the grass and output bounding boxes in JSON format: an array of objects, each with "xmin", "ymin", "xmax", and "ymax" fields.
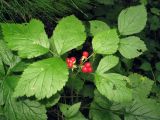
[{"xmin": 1, "ymin": 19, "xmax": 49, "ymax": 58}]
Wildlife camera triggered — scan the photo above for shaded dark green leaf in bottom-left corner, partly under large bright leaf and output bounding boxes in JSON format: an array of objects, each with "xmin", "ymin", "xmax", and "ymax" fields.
[{"xmin": 3, "ymin": 76, "xmax": 47, "ymax": 120}]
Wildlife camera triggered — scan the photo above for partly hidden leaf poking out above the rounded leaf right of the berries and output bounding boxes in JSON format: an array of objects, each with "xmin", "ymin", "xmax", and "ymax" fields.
[{"xmin": 89, "ymin": 20, "xmax": 110, "ymax": 36}]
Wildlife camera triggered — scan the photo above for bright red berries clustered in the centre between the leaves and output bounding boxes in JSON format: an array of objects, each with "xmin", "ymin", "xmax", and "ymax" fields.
[{"xmin": 66, "ymin": 51, "xmax": 93, "ymax": 73}]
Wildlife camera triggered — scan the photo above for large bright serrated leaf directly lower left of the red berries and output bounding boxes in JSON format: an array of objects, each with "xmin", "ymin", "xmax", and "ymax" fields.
[{"xmin": 14, "ymin": 57, "xmax": 68, "ymax": 99}]
